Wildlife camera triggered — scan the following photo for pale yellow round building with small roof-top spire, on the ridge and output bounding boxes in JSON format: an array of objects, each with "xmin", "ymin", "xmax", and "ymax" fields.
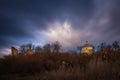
[{"xmin": 81, "ymin": 41, "xmax": 94, "ymax": 55}]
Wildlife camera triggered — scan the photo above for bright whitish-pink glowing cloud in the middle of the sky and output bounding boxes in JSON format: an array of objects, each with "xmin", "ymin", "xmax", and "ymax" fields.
[{"xmin": 44, "ymin": 22, "xmax": 80, "ymax": 47}]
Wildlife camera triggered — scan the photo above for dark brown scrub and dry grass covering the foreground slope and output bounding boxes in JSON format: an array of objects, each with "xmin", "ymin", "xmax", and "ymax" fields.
[{"xmin": 0, "ymin": 52, "xmax": 120, "ymax": 80}]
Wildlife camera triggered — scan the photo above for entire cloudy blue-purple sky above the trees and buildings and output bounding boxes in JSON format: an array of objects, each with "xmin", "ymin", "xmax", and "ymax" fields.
[{"xmin": 0, "ymin": 0, "xmax": 120, "ymax": 56}]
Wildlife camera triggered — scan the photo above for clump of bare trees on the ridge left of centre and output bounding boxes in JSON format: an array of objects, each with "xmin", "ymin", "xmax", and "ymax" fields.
[{"xmin": 19, "ymin": 41, "xmax": 61, "ymax": 53}]
